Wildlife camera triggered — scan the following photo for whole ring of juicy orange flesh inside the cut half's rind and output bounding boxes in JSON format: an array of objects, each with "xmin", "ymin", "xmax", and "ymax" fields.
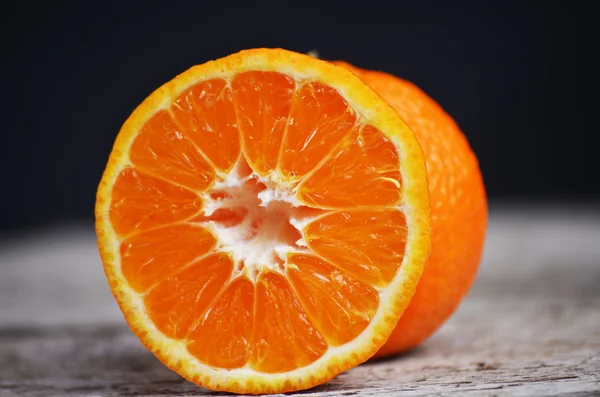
[{"xmin": 110, "ymin": 72, "xmax": 407, "ymax": 373}]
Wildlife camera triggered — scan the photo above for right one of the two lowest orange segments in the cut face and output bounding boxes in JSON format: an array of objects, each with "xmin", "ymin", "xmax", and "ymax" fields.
[{"xmin": 250, "ymin": 272, "xmax": 327, "ymax": 373}]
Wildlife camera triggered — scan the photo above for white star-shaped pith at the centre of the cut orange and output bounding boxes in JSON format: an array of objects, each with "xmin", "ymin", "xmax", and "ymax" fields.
[{"xmin": 203, "ymin": 159, "xmax": 318, "ymax": 282}]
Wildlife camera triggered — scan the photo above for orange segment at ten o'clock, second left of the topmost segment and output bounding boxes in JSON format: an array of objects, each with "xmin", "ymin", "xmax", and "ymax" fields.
[{"xmin": 129, "ymin": 110, "xmax": 215, "ymax": 190}]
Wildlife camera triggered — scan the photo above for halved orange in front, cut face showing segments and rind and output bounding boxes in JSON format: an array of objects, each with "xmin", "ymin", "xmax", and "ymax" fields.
[{"xmin": 95, "ymin": 49, "xmax": 430, "ymax": 393}]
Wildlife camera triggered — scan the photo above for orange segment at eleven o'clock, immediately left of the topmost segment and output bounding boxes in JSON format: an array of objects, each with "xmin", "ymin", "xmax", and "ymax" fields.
[{"xmin": 170, "ymin": 79, "xmax": 240, "ymax": 171}]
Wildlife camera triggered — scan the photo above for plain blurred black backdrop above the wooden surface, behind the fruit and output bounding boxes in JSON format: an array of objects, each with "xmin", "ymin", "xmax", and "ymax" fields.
[{"xmin": 0, "ymin": 1, "xmax": 600, "ymax": 233}]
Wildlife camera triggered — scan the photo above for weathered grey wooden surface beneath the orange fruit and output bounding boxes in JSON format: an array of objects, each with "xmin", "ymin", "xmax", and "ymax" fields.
[{"xmin": 0, "ymin": 208, "xmax": 600, "ymax": 397}]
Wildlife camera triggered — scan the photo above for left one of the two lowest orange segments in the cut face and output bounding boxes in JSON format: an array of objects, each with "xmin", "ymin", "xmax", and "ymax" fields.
[{"xmin": 187, "ymin": 277, "xmax": 254, "ymax": 369}]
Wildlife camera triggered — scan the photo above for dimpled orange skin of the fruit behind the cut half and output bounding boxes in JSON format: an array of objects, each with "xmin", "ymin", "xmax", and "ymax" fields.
[{"xmin": 333, "ymin": 62, "xmax": 488, "ymax": 358}]
